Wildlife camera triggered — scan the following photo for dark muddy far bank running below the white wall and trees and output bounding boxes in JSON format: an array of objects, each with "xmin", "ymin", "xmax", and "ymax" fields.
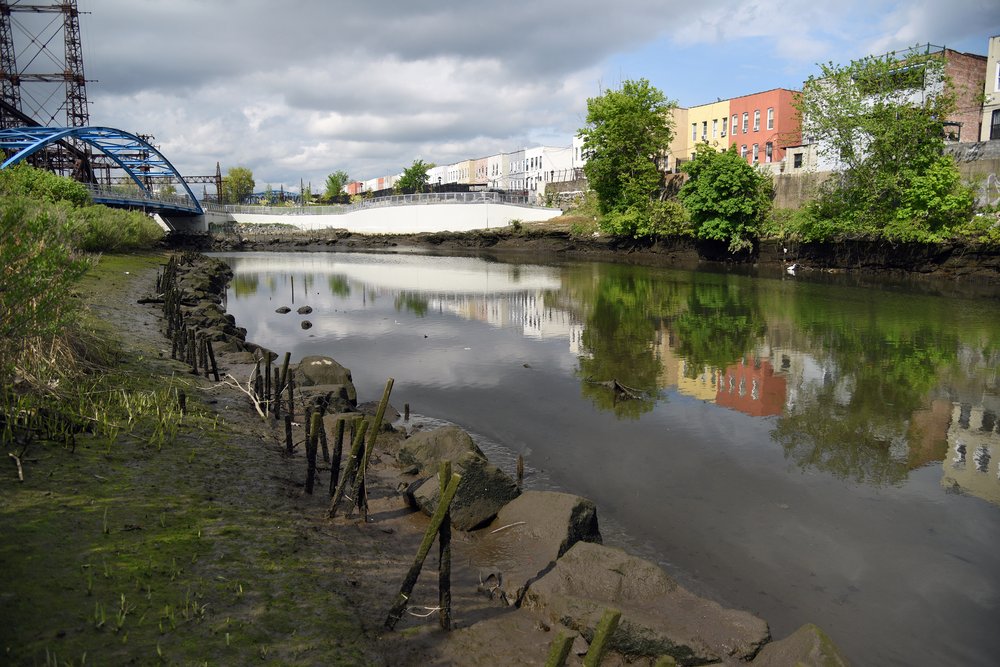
[{"xmin": 168, "ymin": 218, "xmax": 1000, "ymax": 290}]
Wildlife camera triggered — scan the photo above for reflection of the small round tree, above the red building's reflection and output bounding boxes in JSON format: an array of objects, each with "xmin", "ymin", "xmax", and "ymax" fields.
[{"xmin": 672, "ymin": 276, "xmax": 767, "ymax": 370}]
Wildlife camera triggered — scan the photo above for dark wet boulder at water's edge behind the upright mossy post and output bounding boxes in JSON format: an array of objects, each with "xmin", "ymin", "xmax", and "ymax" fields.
[{"xmin": 404, "ymin": 452, "xmax": 520, "ymax": 530}]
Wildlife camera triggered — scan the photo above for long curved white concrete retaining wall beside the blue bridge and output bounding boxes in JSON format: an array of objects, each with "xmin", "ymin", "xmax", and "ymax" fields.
[{"xmin": 232, "ymin": 202, "xmax": 562, "ymax": 234}]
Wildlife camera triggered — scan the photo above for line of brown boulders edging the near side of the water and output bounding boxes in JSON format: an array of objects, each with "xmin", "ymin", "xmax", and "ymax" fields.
[{"xmin": 160, "ymin": 252, "xmax": 846, "ymax": 665}]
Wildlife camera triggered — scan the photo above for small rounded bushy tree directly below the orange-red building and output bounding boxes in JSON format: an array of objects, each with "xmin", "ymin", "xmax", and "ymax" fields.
[{"xmin": 677, "ymin": 144, "xmax": 773, "ymax": 252}]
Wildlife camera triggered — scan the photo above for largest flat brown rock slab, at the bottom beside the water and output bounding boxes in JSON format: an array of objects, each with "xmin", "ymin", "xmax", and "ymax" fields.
[{"xmin": 522, "ymin": 542, "xmax": 769, "ymax": 665}]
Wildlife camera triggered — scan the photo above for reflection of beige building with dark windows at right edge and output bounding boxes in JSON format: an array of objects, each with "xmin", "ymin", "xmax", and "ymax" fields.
[{"xmin": 941, "ymin": 403, "xmax": 1000, "ymax": 505}]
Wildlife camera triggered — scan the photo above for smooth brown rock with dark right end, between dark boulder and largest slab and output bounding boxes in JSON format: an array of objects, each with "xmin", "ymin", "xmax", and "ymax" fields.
[{"xmin": 474, "ymin": 491, "xmax": 601, "ymax": 605}]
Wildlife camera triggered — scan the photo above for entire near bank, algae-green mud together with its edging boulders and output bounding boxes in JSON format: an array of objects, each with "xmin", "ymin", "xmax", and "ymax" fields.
[{"xmin": 0, "ymin": 254, "xmax": 843, "ymax": 665}]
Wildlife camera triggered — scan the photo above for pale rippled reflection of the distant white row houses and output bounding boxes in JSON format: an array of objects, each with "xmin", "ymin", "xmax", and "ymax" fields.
[{"xmin": 427, "ymin": 291, "xmax": 584, "ymax": 354}]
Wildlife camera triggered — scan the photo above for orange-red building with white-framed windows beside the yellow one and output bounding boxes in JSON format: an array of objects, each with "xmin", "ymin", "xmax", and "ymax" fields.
[{"xmin": 729, "ymin": 88, "xmax": 802, "ymax": 164}]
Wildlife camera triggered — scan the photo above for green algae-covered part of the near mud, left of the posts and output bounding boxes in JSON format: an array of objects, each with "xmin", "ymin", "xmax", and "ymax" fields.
[{"xmin": 0, "ymin": 255, "xmax": 375, "ymax": 665}]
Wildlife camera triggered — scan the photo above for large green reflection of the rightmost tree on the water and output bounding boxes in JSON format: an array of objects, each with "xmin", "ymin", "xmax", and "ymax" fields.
[{"xmin": 772, "ymin": 322, "xmax": 958, "ymax": 485}]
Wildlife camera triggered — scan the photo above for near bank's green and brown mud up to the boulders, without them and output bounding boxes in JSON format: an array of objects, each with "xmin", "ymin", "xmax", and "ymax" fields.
[{"xmin": 2, "ymin": 253, "xmax": 852, "ymax": 664}]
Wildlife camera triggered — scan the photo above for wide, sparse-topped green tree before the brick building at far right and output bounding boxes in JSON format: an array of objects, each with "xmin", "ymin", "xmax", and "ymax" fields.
[{"xmin": 797, "ymin": 47, "xmax": 972, "ymax": 241}]
